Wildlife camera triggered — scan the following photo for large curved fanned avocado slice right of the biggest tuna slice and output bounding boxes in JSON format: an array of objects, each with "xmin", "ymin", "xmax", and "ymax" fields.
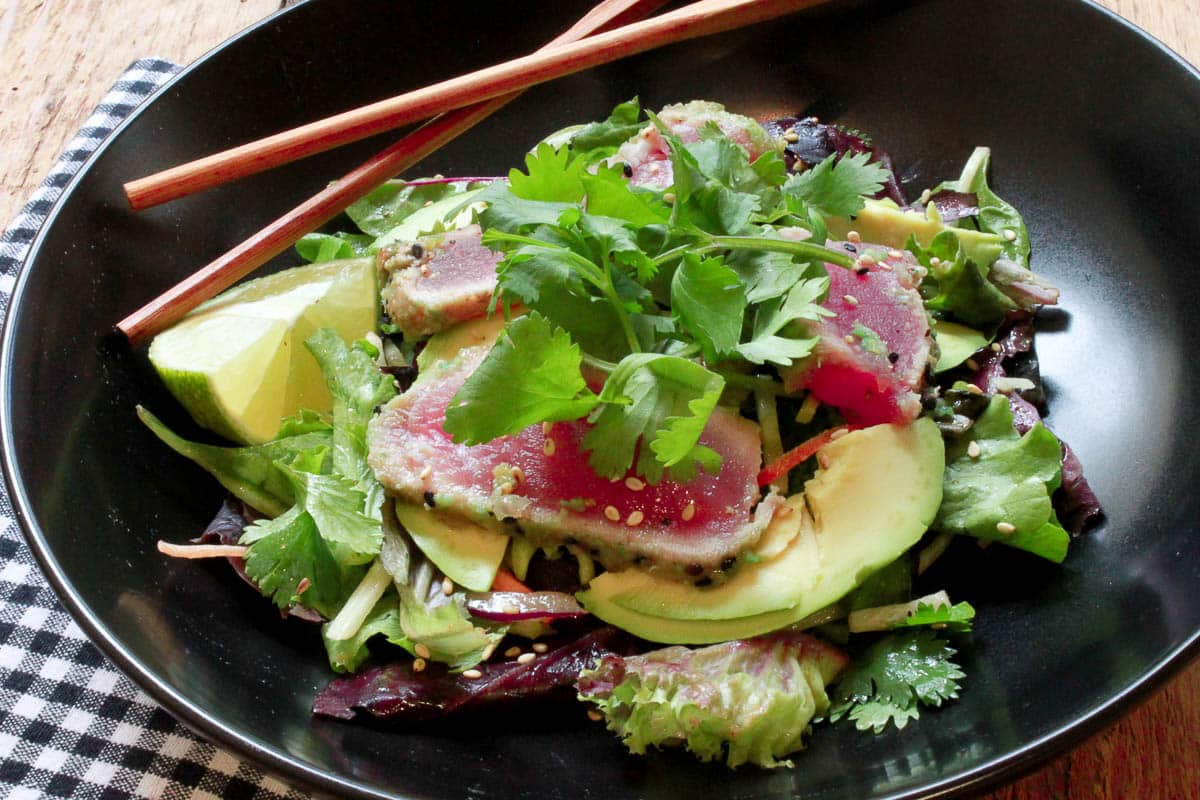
[{"xmin": 580, "ymin": 419, "xmax": 944, "ymax": 644}]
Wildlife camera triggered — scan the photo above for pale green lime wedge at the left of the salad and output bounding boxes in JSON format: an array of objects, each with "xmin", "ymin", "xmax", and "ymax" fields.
[{"xmin": 150, "ymin": 259, "xmax": 379, "ymax": 444}]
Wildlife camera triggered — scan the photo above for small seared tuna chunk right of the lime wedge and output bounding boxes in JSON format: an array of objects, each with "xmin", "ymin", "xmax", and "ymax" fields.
[{"xmin": 379, "ymin": 225, "xmax": 499, "ymax": 338}]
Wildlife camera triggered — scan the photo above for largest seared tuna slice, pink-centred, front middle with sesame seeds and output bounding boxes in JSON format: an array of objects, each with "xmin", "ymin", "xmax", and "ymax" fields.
[{"xmin": 367, "ymin": 323, "xmax": 779, "ymax": 577}]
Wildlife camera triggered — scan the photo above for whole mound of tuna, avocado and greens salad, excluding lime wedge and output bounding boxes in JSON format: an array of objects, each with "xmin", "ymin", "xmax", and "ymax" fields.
[{"xmin": 139, "ymin": 100, "xmax": 1098, "ymax": 766}]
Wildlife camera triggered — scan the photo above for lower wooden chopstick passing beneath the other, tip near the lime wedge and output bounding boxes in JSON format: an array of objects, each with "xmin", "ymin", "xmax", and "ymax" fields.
[{"xmin": 116, "ymin": 0, "xmax": 668, "ymax": 344}]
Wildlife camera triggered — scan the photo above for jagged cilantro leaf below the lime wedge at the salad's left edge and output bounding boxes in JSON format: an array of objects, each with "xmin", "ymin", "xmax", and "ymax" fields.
[{"xmin": 241, "ymin": 506, "xmax": 344, "ymax": 619}]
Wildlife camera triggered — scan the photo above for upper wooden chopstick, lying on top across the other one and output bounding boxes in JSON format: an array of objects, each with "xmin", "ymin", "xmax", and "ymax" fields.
[{"xmin": 125, "ymin": 0, "xmax": 821, "ymax": 209}]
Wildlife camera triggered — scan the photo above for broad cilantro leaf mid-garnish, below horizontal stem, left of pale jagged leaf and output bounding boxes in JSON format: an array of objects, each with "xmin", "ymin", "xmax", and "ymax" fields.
[{"xmin": 671, "ymin": 253, "xmax": 746, "ymax": 361}]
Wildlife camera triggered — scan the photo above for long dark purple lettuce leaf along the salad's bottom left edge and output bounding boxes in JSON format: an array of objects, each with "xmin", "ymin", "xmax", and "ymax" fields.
[{"xmin": 312, "ymin": 627, "xmax": 634, "ymax": 720}]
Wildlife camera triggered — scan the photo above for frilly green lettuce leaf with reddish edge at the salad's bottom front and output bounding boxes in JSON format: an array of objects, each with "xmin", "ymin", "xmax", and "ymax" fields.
[{"xmin": 577, "ymin": 631, "xmax": 847, "ymax": 766}]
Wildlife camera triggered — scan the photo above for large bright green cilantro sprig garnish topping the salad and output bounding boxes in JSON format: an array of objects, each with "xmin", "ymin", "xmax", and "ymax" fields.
[{"xmin": 445, "ymin": 101, "xmax": 886, "ymax": 482}]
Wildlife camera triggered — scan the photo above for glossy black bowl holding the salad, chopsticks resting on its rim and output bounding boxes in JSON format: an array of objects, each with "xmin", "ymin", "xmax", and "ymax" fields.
[{"xmin": 0, "ymin": 0, "xmax": 1200, "ymax": 798}]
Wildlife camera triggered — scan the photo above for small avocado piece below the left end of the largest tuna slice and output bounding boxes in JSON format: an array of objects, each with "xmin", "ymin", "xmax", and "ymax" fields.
[{"xmin": 396, "ymin": 500, "xmax": 509, "ymax": 591}]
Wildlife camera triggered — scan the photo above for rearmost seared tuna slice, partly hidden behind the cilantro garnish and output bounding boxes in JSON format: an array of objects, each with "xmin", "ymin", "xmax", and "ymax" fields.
[{"xmin": 608, "ymin": 100, "xmax": 772, "ymax": 191}]
